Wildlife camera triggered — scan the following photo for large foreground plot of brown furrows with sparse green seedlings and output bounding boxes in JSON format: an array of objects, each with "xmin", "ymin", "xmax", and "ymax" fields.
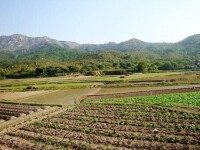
[{"xmin": 0, "ymin": 92, "xmax": 200, "ymax": 149}]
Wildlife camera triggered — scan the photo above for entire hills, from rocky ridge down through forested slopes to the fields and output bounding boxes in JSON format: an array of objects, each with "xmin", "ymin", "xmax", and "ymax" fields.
[{"xmin": 0, "ymin": 34, "xmax": 200, "ymax": 76}]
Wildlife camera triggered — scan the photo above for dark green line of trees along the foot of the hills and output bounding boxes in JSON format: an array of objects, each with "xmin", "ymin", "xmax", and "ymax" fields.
[{"xmin": 0, "ymin": 60, "xmax": 197, "ymax": 78}]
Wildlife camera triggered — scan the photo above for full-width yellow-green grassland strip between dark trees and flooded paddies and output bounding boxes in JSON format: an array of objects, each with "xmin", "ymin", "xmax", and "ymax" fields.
[{"xmin": 0, "ymin": 71, "xmax": 200, "ymax": 91}]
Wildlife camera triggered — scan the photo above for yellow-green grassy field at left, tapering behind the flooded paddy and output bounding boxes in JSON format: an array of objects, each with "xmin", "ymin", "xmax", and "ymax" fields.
[{"xmin": 0, "ymin": 77, "xmax": 101, "ymax": 91}]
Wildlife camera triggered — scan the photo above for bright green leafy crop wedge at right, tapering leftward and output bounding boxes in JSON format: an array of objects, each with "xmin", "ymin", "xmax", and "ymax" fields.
[{"xmin": 85, "ymin": 92, "xmax": 200, "ymax": 110}]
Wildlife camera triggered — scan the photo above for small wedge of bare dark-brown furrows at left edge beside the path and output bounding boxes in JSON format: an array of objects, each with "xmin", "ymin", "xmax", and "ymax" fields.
[{"xmin": 0, "ymin": 103, "xmax": 46, "ymax": 123}]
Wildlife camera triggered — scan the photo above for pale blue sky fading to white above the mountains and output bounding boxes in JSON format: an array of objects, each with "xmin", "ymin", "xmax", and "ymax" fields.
[{"xmin": 0, "ymin": 0, "xmax": 200, "ymax": 44}]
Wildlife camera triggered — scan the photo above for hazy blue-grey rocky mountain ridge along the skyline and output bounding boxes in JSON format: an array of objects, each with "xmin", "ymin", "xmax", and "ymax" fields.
[{"xmin": 0, "ymin": 34, "xmax": 200, "ymax": 52}]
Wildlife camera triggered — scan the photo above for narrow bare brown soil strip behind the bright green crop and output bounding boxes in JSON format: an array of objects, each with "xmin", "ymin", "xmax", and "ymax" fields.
[{"xmin": 83, "ymin": 87, "xmax": 200, "ymax": 100}]
